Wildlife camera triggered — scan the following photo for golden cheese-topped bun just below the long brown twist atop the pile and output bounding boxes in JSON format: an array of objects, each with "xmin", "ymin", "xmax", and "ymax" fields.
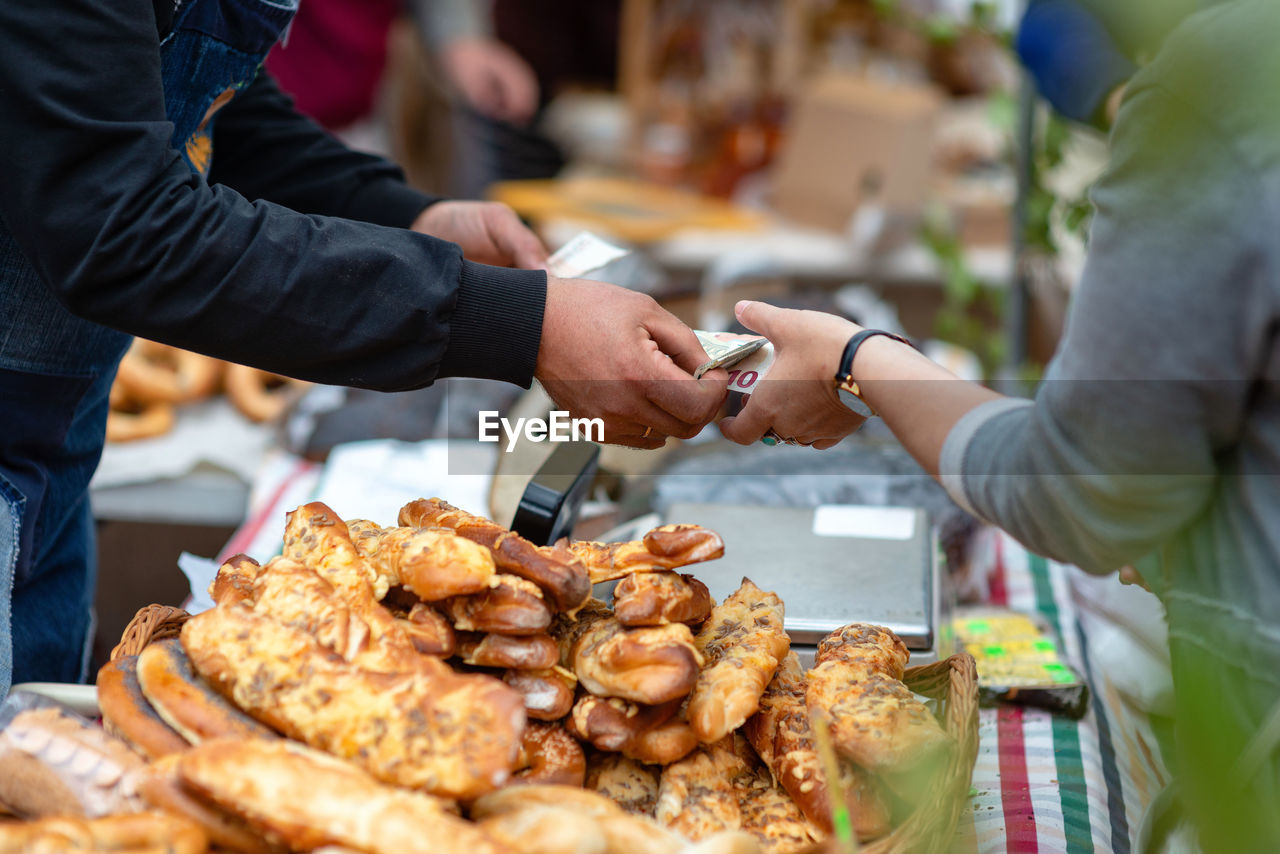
[{"xmin": 347, "ymin": 519, "xmax": 495, "ymax": 602}]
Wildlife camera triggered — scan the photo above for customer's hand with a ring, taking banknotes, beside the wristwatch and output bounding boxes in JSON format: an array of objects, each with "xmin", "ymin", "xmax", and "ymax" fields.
[{"xmin": 719, "ymin": 301, "xmax": 865, "ymax": 448}]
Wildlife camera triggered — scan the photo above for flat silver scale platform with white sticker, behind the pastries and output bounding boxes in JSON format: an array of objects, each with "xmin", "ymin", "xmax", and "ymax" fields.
[{"xmin": 663, "ymin": 503, "xmax": 945, "ymax": 666}]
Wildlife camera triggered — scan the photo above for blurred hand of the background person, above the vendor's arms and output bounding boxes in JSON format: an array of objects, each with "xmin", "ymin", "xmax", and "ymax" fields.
[{"xmin": 440, "ymin": 38, "xmax": 538, "ymax": 124}]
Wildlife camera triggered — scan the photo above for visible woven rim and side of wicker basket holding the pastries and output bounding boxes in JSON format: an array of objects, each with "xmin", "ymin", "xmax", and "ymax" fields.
[{"xmin": 111, "ymin": 604, "xmax": 978, "ymax": 854}]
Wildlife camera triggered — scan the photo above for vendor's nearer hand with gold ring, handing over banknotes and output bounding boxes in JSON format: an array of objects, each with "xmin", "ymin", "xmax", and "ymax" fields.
[{"xmin": 535, "ymin": 278, "xmax": 728, "ymax": 448}]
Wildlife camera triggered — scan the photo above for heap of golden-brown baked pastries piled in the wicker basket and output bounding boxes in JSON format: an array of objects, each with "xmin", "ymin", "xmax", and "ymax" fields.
[{"xmin": 0, "ymin": 499, "xmax": 967, "ymax": 854}]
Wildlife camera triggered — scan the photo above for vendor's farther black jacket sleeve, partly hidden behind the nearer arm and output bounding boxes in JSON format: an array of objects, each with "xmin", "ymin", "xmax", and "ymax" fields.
[{"xmin": 209, "ymin": 70, "xmax": 439, "ymax": 228}]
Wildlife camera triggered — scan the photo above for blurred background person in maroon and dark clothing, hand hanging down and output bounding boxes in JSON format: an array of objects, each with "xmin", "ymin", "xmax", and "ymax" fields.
[{"xmin": 268, "ymin": 0, "xmax": 621, "ymax": 198}]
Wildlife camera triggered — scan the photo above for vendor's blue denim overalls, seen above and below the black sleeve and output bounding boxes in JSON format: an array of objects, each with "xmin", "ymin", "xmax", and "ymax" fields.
[{"xmin": 0, "ymin": 0, "xmax": 297, "ymax": 698}]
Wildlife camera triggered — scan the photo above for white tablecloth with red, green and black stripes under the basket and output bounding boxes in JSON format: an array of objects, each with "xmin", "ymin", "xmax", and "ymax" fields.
[{"xmin": 220, "ymin": 457, "xmax": 1169, "ymax": 854}]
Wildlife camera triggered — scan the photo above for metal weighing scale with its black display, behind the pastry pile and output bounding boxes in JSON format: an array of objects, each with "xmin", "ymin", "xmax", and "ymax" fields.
[{"xmin": 512, "ymin": 443, "xmax": 951, "ymax": 667}]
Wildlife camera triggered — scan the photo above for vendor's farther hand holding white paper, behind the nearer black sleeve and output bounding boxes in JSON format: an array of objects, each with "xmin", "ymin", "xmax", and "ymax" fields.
[{"xmin": 411, "ymin": 201, "xmax": 547, "ymax": 270}]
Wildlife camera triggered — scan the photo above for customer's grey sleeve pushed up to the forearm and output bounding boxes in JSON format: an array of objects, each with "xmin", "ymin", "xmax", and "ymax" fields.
[{"xmin": 940, "ymin": 78, "xmax": 1274, "ymax": 572}]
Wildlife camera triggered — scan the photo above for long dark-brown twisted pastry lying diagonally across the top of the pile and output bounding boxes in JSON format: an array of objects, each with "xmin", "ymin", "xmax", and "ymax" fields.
[{"xmin": 399, "ymin": 498, "xmax": 591, "ymax": 612}]
